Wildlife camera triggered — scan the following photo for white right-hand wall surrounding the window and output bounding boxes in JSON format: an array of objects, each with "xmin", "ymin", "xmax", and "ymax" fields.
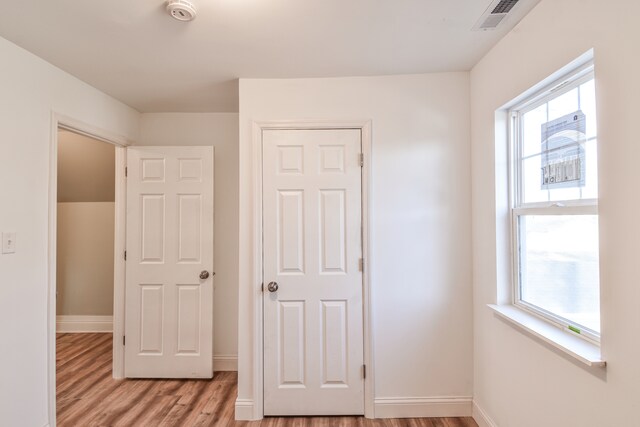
[{"xmin": 471, "ymin": 0, "xmax": 640, "ymax": 427}]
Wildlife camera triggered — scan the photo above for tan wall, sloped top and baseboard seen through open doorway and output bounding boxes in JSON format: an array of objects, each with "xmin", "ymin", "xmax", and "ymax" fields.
[{"xmin": 56, "ymin": 129, "xmax": 116, "ymax": 333}]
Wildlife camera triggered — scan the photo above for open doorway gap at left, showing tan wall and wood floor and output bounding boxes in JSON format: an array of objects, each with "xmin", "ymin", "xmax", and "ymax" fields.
[{"xmin": 55, "ymin": 127, "xmax": 116, "ymax": 422}]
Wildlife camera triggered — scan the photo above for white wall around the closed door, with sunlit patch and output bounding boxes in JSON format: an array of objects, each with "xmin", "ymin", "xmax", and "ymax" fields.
[{"xmin": 238, "ymin": 73, "xmax": 472, "ymax": 415}]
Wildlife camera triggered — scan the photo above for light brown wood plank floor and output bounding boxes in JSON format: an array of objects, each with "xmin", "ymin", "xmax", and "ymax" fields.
[{"xmin": 56, "ymin": 334, "xmax": 477, "ymax": 427}]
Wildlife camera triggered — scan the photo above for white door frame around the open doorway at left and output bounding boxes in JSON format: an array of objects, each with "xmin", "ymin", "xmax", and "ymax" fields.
[{"xmin": 47, "ymin": 111, "xmax": 132, "ymax": 427}]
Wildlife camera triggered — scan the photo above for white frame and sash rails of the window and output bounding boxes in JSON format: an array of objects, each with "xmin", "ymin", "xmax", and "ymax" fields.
[{"xmin": 508, "ymin": 61, "xmax": 600, "ymax": 345}]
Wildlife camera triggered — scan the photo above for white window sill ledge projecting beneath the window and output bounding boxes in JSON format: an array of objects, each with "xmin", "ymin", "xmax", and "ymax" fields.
[{"xmin": 487, "ymin": 304, "xmax": 607, "ymax": 367}]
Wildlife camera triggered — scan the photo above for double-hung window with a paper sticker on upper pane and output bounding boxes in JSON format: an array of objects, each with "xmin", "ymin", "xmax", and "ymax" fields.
[{"xmin": 510, "ymin": 64, "xmax": 600, "ymax": 342}]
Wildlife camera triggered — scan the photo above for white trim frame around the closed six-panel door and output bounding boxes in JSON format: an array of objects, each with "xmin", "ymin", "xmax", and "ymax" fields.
[{"xmin": 246, "ymin": 120, "xmax": 375, "ymax": 419}]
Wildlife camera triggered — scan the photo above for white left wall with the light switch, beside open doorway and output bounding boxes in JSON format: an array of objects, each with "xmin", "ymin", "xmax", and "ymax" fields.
[{"xmin": 0, "ymin": 38, "xmax": 138, "ymax": 426}]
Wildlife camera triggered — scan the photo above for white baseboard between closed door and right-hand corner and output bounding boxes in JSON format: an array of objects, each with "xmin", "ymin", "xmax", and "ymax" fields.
[{"xmin": 374, "ymin": 396, "xmax": 473, "ymax": 418}]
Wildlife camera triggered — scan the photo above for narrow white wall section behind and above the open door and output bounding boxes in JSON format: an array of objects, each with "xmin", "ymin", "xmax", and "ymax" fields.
[{"xmin": 138, "ymin": 113, "xmax": 238, "ymax": 370}]
